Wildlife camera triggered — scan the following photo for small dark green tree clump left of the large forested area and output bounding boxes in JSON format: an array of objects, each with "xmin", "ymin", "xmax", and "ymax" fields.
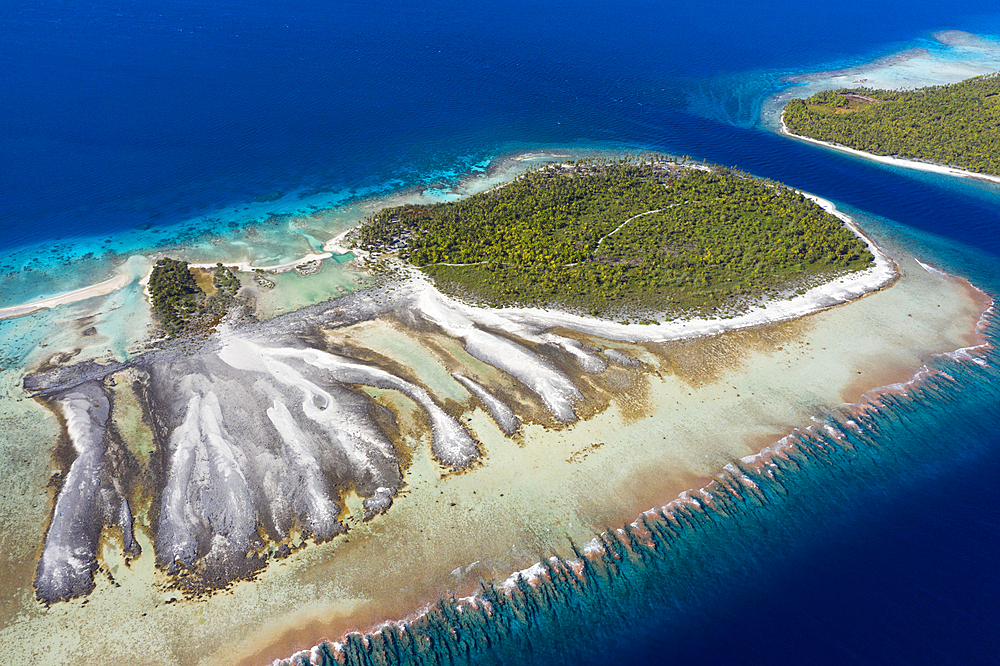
[{"xmin": 149, "ymin": 257, "xmax": 240, "ymax": 337}]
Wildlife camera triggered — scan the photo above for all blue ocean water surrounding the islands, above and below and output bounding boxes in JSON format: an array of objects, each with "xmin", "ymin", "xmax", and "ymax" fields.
[{"xmin": 0, "ymin": 0, "xmax": 1000, "ymax": 664}]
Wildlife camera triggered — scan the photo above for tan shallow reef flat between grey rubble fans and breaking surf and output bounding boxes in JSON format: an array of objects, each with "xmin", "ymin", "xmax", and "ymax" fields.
[{"xmin": 6, "ymin": 224, "xmax": 981, "ymax": 665}]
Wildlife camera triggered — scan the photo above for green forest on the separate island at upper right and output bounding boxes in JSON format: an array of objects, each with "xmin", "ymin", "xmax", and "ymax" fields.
[{"xmin": 784, "ymin": 74, "xmax": 1000, "ymax": 175}]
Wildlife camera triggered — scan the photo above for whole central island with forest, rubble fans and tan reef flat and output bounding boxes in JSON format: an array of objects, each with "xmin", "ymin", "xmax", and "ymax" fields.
[{"xmin": 11, "ymin": 156, "xmax": 989, "ymax": 664}]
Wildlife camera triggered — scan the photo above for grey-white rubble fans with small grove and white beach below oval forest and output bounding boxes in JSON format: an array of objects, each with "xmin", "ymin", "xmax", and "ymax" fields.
[{"xmin": 24, "ymin": 182, "xmax": 896, "ymax": 603}]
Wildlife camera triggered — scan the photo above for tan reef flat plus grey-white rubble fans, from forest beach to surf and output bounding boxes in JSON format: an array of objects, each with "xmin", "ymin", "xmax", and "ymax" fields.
[{"xmin": 3, "ymin": 209, "xmax": 986, "ymax": 664}]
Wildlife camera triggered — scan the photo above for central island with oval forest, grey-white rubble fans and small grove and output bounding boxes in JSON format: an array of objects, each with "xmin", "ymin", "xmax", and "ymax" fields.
[{"xmin": 25, "ymin": 156, "xmax": 895, "ymax": 603}]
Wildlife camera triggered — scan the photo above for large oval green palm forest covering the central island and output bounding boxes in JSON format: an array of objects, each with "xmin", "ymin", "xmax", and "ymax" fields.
[{"xmin": 353, "ymin": 156, "xmax": 873, "ymax": 318}]
